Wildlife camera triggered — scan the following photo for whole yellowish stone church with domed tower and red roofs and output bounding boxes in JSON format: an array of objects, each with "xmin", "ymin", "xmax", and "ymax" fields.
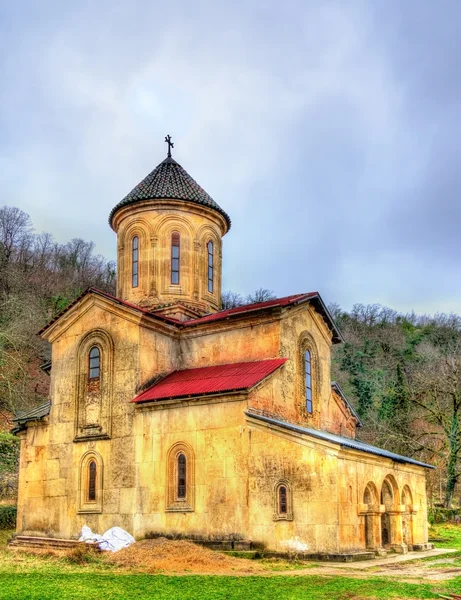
[{"xmin": 12, "ymin": 138, "xmax": 430, "ymax": 555}]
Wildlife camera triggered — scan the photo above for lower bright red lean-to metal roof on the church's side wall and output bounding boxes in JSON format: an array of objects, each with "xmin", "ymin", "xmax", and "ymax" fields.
[{"xmin": 132, "ymin": 358, "xmax": 287, "ymax": 403}]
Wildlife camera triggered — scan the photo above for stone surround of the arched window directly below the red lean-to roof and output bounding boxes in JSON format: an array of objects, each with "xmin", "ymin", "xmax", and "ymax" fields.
[{"xmin": 165, "ymin": 442, "xmax": 195, "ymax": 512}]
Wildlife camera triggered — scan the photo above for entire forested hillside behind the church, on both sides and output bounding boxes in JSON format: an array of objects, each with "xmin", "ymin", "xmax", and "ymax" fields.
[{"xmin": 0, "ymin": 206, "xmax": 461, "ymax": 507}]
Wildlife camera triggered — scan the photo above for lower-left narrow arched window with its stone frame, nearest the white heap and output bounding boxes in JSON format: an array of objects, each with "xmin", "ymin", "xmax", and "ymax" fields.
[{"xmin": 78, "ymin": 450, "xmax": 104, "ymax": 513}]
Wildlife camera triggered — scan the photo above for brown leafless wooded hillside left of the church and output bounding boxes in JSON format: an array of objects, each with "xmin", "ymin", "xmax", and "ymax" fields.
[{"xmin": 0, "ymin": 206, "xmax": 115, "ymax": 415}]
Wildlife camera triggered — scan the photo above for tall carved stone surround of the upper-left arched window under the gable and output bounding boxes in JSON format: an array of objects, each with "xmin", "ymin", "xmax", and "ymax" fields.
[{"xmin": 75, "ymin": 329, "xmax": 114, "ymax": 441}]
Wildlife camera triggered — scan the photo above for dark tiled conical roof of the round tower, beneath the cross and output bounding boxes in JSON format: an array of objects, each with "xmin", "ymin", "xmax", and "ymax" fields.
[{"xmin": 109, "ymin": 157, "xmax": 231, "ymax": 229}]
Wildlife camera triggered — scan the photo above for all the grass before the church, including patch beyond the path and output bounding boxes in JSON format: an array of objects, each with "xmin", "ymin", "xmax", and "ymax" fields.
[{"xmin": 0, "ymin": 526, "xmax": 461, "ymax": 600}]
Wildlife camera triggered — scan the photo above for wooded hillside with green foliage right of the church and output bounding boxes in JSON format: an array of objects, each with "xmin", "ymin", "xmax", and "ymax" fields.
[{"xmin": 332, "ymin": 305, "xmax": 461, "ymax": 500}]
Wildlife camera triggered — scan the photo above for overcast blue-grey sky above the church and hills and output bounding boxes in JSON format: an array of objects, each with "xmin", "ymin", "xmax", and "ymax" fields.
[{"xmin": 0, "ymin": 0, "xmax": 461, "ymax": 313}]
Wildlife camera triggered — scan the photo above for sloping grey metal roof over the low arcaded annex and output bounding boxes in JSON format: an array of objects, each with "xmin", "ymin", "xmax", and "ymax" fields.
[{"xmin": 245, "ymin": 412, "xmax": 435, "ymax": 469}]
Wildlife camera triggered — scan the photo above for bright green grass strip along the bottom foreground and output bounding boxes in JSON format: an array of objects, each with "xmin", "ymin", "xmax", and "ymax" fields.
[{"xmin": 0, "ymin": 571, "xmax": 452, "ymax": 600}]
